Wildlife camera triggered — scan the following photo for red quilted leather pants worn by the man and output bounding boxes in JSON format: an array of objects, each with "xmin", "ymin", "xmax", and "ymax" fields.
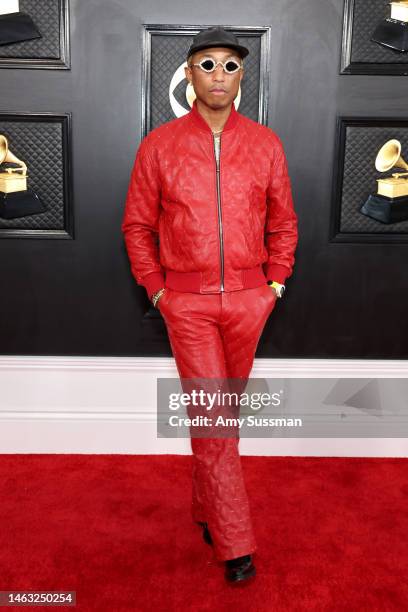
[{"xmin": 158, "ymin": 283, "xmax": 277, "ymax": 561}]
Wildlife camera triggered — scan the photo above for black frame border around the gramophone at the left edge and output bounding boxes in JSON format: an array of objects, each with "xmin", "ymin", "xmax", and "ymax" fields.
[{"xmin": 0, "ymin": 111, "xmax": 74, "ymax": 240}]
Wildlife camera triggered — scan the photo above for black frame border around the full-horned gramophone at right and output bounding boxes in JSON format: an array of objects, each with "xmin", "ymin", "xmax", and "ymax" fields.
[{"xmin": 329, "ymin": 116, "xmax": 408, "ymax": 244}]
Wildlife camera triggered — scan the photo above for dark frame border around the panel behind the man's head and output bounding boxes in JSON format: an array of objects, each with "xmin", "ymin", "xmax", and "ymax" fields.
[{"xmin": 141, "ymin": 24, "xmax": 271, "ymax": 139}]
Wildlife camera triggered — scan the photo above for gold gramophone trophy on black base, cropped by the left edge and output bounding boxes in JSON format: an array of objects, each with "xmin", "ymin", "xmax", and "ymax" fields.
[{"xmin": 0, "ymin": 134, "xmax": 46, "ymax": 219}]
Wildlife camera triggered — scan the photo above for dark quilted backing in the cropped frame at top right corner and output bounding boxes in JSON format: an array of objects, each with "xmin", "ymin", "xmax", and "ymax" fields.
[{"xmin": 351, "ymin": 0, "xmax": 408, "ymax": 64}]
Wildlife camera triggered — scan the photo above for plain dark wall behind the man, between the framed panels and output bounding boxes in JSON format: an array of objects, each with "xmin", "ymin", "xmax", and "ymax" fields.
[{"xmin": 0, "ymin": 0, "xmax": 408, "ymax": 359}]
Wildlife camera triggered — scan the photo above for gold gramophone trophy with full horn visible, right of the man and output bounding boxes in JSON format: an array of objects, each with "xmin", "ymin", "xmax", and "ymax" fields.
[{"xmin": 361, "ymin": 139, "xmax": 408, "ymax": 223}]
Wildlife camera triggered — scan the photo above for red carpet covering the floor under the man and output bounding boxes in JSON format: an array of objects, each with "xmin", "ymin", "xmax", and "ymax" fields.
[{"xmin": 0, "ymin": 455, "xmax": 408, "ymax": 612}]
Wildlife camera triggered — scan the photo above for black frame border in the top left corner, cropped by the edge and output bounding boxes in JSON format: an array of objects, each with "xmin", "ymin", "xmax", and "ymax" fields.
[{"xmin": 0, "ymin": 0, "xmax": 71, "ymax": 70}]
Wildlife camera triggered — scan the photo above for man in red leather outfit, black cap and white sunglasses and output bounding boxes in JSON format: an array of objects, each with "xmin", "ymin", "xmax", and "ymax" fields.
[{"xmin": 122, "ymin": 28, "xmax": 298, "ymax": 582}]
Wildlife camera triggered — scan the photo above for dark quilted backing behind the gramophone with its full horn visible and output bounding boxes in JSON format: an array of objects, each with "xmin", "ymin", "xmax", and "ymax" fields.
[{"xmin": 340, "ymin": 126, "xmax": 408, "ymax": 234}]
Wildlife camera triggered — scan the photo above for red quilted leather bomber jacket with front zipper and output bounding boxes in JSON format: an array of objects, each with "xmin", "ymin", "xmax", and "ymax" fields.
[{"xmin": 121, "ymin": 101, "xmax": 298, "ymax": 297}]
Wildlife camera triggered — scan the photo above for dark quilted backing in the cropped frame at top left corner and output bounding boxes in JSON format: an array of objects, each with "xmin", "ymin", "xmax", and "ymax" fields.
[{"xmin": 0, "ymin": 0, "xmax": 62, "ymax": 59}]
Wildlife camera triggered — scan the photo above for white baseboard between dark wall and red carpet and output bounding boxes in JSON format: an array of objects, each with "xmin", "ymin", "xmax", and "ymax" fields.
[{"xmin": 0, "ymin": 356, "xmax": 408, "ymax": 457}]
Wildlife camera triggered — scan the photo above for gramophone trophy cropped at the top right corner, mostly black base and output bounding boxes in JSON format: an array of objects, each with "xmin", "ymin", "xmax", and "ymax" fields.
[{"xmin": 371, "ymin": 0, "xmax": 408, "ymax": 53}]
